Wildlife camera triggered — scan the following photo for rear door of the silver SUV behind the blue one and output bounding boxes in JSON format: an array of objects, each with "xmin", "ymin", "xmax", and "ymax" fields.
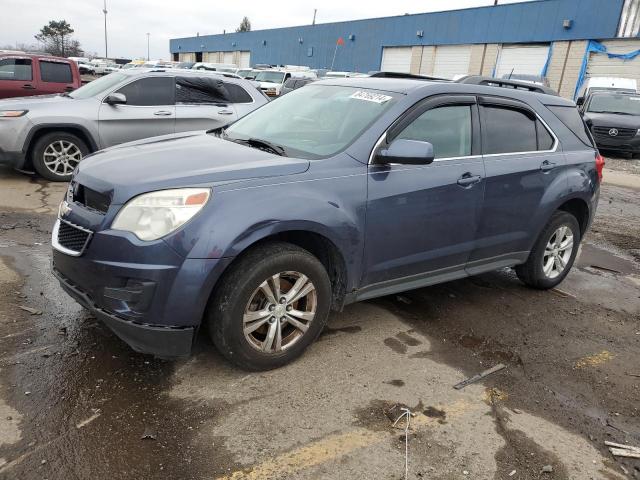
[{"xmin": 176, "ymin": 75, "xmax": 238, "ymax": 132}]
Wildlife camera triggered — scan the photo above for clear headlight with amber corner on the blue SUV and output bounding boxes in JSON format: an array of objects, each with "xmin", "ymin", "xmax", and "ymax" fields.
[{"xmin": 111, "ymin": 188, "xmax": 211, "ymax": 240}]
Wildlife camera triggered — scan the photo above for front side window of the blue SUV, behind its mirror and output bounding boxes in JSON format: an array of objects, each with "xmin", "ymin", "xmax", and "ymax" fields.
[{"xmin": 396, "ymin": 105, "xmax": 471, "ymax": 158}]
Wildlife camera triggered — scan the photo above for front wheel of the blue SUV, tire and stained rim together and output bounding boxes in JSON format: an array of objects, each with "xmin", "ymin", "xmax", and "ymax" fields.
[{"xmin": 207, "ymin": 242, "xmax": 332, "ymax": 371}]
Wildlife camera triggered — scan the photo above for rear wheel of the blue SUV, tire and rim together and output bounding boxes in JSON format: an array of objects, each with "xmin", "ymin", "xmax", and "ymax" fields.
[{"xmin": 515, "ymin": 211, "xmax": 581, "ymax": 290}]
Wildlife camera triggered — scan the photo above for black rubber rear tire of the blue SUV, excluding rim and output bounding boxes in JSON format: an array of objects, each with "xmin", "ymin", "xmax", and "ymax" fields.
[{"xmin": 515, "ymin": 211, "xmax": 581, "ymax": 290}]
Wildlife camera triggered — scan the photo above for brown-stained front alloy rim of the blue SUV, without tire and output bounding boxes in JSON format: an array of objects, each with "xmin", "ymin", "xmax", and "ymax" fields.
[{"xmin": 243, "ymin": 271, "xmax": 318, "ymax": 354}]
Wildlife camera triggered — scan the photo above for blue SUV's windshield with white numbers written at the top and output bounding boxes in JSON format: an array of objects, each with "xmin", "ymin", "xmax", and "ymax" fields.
[{"xmin": 225, "ymin": 85, "xmax": 395, "ymax": 159}]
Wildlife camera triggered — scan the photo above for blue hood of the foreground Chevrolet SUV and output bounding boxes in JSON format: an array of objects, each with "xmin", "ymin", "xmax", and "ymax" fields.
[{"xmin": 74, "ymin": 132, "xmax": 309, "ymax": 205}]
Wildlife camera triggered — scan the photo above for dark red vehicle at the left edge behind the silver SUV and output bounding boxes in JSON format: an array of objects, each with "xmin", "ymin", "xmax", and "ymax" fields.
[{"xmin": 0, "ymin": 53, "xmax": 82, "ymax": 98}]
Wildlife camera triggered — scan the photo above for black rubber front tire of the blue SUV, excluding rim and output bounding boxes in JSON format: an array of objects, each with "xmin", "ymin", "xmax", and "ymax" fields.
[{"xmin": 207, "ymin": 242, "xmax": 331, "ymax": 371}]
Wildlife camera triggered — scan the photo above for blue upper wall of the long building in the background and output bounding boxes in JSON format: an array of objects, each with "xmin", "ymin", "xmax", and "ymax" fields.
[{"xmin": 170, "ymin": 0, "xmax": 624, "ymax": 72}]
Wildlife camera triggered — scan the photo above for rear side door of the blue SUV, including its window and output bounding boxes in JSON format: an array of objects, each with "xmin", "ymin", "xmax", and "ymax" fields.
[{"xmin": 469, "ymin": 96, "xmax": 565, "ymax": 273}]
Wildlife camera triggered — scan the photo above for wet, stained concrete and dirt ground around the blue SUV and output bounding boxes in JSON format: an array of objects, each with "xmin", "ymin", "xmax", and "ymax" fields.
[{"xmin": 0, "ymin": 160, "xmax": 640, "ymax": 480}]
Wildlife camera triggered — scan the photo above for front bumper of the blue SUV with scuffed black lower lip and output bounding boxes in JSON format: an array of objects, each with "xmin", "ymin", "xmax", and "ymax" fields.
[{"xmin": 52, "ymin": 219, "xmax": 231, "ymax": 357}]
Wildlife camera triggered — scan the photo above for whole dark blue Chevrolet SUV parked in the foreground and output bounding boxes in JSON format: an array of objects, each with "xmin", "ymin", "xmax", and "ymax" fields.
[{"xmin": 52, "ymin": 78, "xmax": 604, "ymax": 370}]
